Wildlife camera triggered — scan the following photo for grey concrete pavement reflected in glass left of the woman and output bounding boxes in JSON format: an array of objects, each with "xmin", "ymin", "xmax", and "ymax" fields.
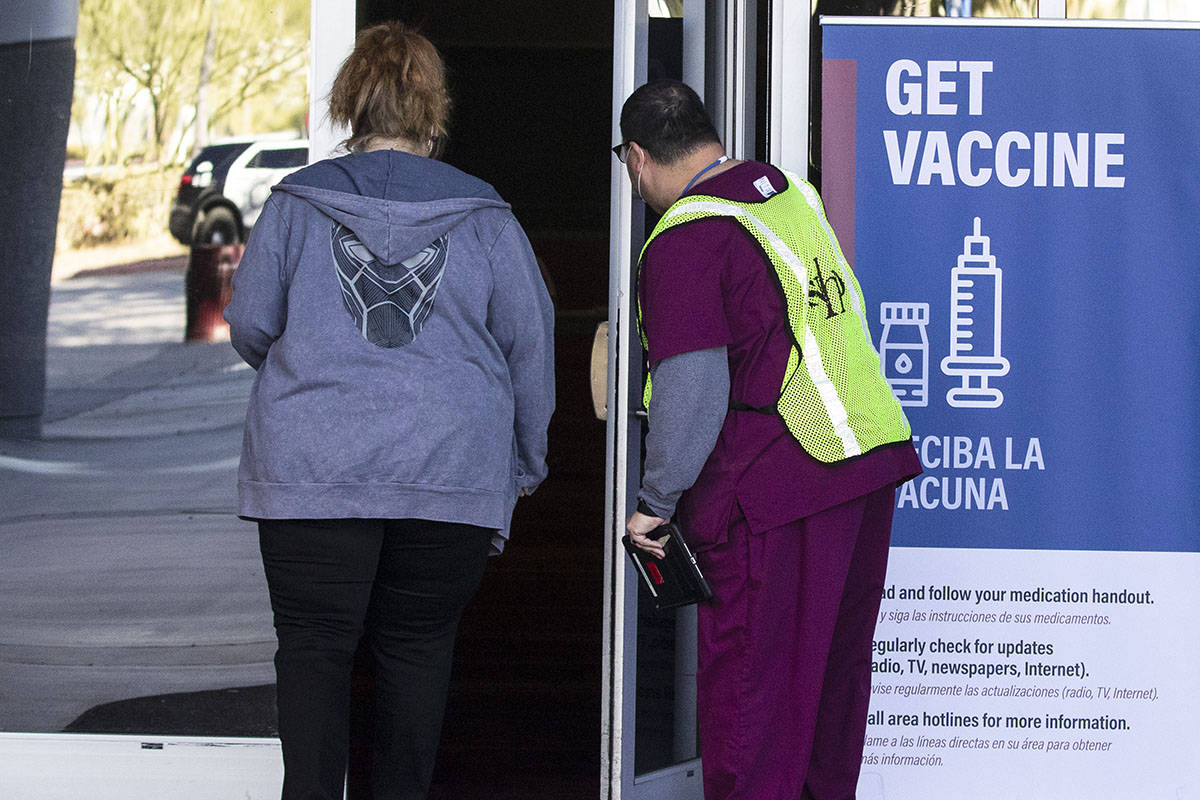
[{"xmin": 0, "ymin": 264, "xmax": 275, "ymax": 735}]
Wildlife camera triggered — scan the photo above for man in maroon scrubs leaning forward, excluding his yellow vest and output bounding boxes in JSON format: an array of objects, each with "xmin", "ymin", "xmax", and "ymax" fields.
[{"xmin": 614, "ymin": 80, "xmax": 920, "ymax": 800}]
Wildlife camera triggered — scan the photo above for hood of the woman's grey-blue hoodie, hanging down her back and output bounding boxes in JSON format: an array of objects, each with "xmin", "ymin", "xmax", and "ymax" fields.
[{"xmin": 272, "ymin": 150, "xmax": 509, "ymax": 264}]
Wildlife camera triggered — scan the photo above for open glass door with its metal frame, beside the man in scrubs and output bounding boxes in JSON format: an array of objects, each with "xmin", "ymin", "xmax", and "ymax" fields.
[{"xmin": 601, "ymin": 0, "xmax": 762, "ymax": 800}]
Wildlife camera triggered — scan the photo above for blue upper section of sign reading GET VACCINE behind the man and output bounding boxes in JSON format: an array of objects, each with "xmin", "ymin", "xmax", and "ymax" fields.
[{"xmin": 821, "ymin": 19, "xmax": 1200, "ymax": 552}]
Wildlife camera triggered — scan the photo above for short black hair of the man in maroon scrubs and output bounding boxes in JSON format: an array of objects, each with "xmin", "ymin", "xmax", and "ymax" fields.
[{"xmin": 620, "ymin": 80, "xmax": 721, "ymax": 164}]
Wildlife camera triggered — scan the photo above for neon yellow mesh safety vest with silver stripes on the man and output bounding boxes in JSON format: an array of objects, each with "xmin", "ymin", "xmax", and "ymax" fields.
[{"xmin": 638, "ymin": 174, "xmax": 912, "ymax": 462}]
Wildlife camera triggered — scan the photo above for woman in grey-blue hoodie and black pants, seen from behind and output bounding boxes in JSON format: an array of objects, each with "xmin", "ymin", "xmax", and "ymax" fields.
[{"xmin": 226, "ymin": 23, "xmax": 554, "ymax": 800}]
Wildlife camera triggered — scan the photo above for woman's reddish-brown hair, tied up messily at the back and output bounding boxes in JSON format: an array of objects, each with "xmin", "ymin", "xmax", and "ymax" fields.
[{"xmin": 329, "ymin": 22, "xmax": 450, "ymax": 156}]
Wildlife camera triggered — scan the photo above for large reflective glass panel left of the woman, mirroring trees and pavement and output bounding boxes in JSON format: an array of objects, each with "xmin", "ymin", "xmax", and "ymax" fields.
[{"xmin": 0, "ymin": 0, "xmax": 310, "ymax": 743}]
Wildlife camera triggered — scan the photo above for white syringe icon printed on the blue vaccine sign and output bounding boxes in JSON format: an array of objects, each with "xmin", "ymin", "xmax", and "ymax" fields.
[{"xmin": 942, "ymin": 217, "xmax": 1008, "ymax": 408}]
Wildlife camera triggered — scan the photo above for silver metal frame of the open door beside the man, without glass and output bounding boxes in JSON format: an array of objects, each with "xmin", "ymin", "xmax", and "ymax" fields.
[{"xmin": 600, "ymin": 0, "xmax": 758, "ymax": 800}]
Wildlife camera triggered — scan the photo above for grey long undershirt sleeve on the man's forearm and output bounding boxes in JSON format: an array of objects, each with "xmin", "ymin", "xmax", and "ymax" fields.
[{"xmin": 637, "ymin": 347, "xmax": 730, "ymax": 519}]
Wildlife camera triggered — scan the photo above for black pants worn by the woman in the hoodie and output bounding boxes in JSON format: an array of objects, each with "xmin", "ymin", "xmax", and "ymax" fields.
[{"xmin": 259, "ymin": 519, "xmax": 492, "ymax": 800}]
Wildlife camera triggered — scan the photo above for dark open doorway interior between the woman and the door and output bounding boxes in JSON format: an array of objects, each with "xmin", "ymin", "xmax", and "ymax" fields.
[{"xmin": 350, "ymin": 0, "xmax": 612, "ymax": 800}]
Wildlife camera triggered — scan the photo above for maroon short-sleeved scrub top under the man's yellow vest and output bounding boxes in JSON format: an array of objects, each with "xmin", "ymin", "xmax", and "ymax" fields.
[{"xmin": 637, "ymin": 162, "xmax": 920, "ymax": 549}]
